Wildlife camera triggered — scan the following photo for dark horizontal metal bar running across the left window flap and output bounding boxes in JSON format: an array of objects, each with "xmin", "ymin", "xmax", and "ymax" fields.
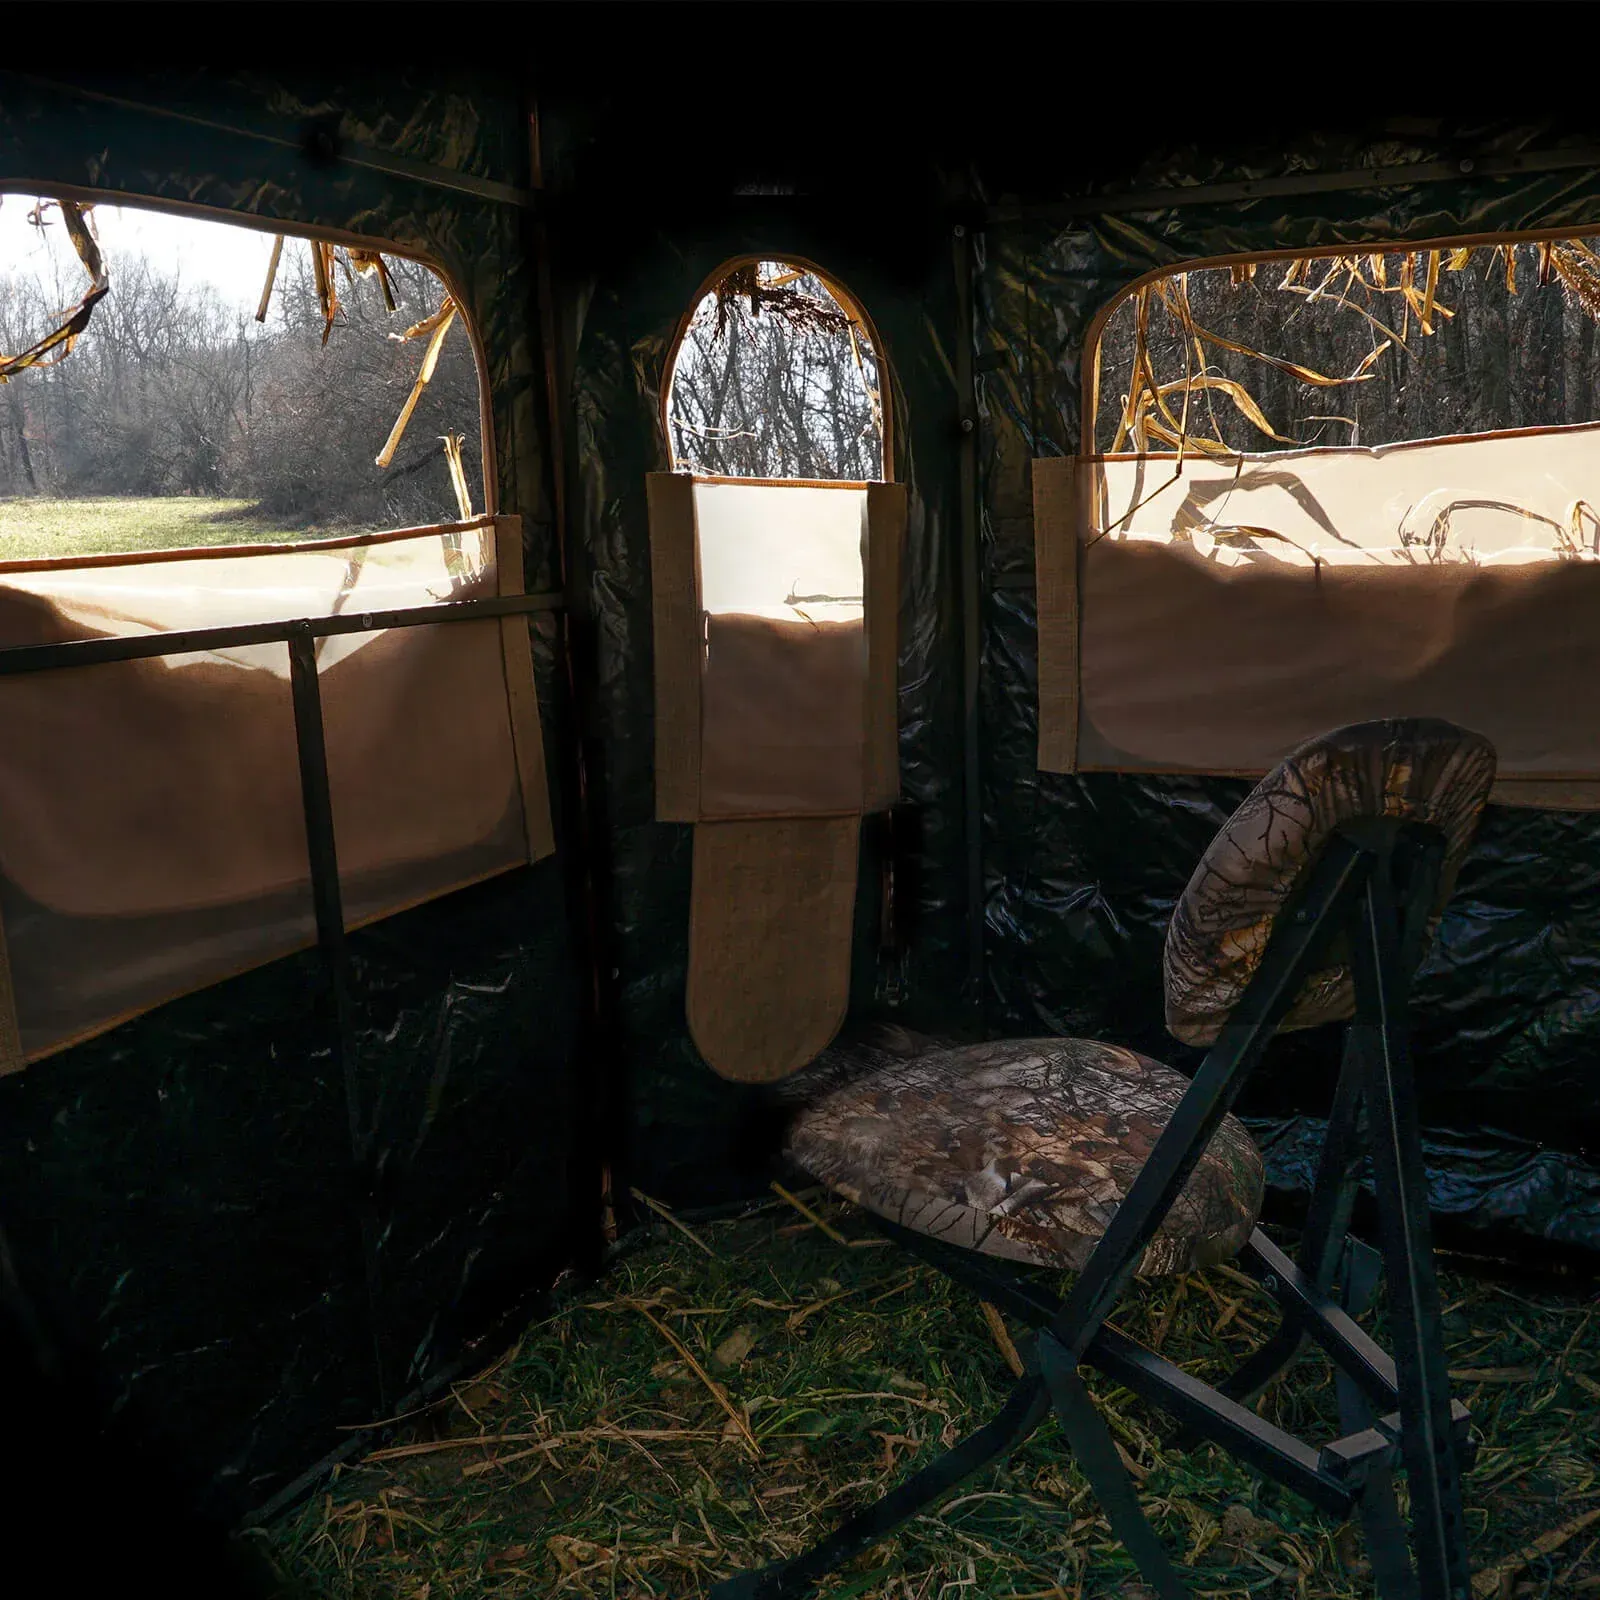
[{"xmin": 0, "ymin": 594, "xmax": 566, "ymax": 677}]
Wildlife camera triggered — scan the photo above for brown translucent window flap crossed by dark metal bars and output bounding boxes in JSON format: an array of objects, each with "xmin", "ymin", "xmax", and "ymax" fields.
[{"xmin": 0, "ymin": 518, "xmax": 549, "ymax": 1066}]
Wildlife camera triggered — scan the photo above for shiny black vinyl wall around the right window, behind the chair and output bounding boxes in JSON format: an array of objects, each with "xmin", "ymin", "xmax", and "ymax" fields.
[{"xmin": 974, "ymin": 130, "xmax": 1600, "ymax": 1261}]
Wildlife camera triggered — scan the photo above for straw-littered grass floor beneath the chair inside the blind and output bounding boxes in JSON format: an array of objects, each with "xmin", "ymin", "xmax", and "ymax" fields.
[{"xmin": 256, "ymin": 1198, "xmax": 1600, "ymax": 1600}]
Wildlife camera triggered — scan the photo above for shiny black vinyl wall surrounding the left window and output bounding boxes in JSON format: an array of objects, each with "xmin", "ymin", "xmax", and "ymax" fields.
[{"xmin": 0, "ymin": 69, "xmax": 588, "ymax": 1517}]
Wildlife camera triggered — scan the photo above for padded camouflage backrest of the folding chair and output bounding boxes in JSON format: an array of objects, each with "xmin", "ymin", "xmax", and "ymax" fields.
[{"xmin": 1163, "ymin": 717, "xmax": 1494, "ymax": 1045}]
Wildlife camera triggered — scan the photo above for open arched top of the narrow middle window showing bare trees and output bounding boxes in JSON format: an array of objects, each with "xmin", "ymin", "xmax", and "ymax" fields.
[{"xmin": 666, "ymin": 261, "xmax": 886, "ymax": 483}]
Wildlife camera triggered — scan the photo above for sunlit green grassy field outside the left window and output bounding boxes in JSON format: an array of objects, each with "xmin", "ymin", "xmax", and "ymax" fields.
[{"xmin": 0, "ymin": 494, "xmax": 349, "ymax": 562}]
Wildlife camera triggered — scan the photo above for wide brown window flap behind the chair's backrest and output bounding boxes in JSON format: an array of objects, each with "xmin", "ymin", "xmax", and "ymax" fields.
[{"xmin": 1034, "ymin": 426, "xmax": 1600, "ymax": 808}]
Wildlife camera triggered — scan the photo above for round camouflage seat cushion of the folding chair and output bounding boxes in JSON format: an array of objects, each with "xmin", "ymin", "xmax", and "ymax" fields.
[{"xmin": 784, "ymin": 1038, "xmax": 1262, "ymax": 1275}]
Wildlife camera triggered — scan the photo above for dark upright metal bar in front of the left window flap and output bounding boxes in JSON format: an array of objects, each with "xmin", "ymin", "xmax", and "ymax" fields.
[{"xmin": 288, "ymin": 622, "xmax": 392, "ymax": 1413}]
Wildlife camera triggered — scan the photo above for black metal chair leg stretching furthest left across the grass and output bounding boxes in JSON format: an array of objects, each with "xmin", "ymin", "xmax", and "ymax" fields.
[{"xmin": 710, "ymin": 1373, "xmax": 1050, "ymax": 1600}]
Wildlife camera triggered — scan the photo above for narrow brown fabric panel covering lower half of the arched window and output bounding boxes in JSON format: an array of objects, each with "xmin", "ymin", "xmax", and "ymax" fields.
[{"xmin": 650, "ymin": 474, "xmax": 904, "ymax": 822}]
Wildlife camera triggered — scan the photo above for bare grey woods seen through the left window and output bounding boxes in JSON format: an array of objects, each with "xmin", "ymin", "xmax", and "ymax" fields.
[{"xmin": 0, "ymin": 222, "xmax": 483, "ymax": 528}]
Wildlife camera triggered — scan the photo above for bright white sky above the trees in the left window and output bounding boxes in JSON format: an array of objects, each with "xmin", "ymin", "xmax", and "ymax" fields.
[{"xmin": 0, "ymin": 194, "xmax": 284, "ymax": 312}]
